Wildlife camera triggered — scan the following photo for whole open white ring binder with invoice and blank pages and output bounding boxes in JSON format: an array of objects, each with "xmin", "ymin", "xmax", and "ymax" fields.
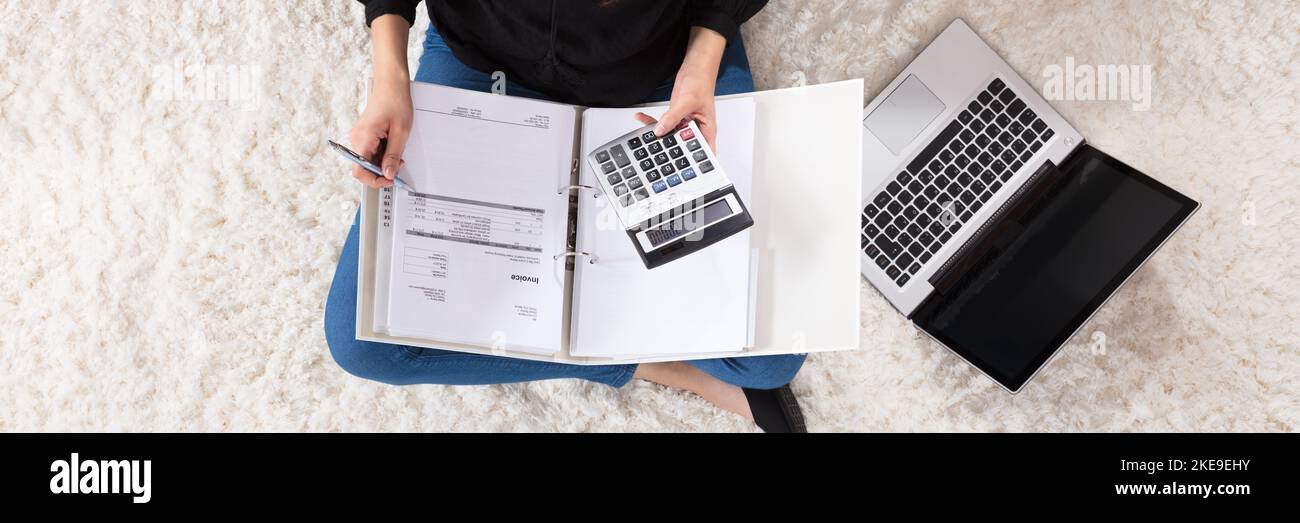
[{"xmin": 356, "ymin": 79, "xmax": 862, "ymax": 364}]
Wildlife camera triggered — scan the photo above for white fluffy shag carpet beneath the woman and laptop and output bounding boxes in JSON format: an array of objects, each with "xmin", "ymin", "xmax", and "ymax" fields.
[{"xmin": 0, "ymin": 0, "xmax": 1300, "ymax": 431}]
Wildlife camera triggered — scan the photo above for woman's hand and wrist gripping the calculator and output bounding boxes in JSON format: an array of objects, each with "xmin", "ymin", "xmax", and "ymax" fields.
[{"xmin": 637, "ymin": 27, "xmax": 727, "ymax": 152}]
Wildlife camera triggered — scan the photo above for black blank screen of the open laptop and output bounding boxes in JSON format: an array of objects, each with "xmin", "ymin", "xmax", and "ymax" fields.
[{"xmin": 913, "ymin": 147, "xmax": 1197, "ymax": 392}]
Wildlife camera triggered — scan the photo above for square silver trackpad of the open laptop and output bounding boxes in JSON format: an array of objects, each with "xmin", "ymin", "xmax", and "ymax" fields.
[{"xmin": 862, "ymin": 74, "xmax": 945, "ymax": 155}]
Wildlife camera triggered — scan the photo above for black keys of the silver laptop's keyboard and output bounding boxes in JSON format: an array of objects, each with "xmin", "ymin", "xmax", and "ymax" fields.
[{"xmin": 862, "ymin": 78, "xmax": 1054, "ymax": 288}]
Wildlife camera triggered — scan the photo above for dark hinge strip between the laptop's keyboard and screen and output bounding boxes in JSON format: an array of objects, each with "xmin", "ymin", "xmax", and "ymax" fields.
[{"xmin": 918, "ymin": 160, "xmax": 1061, "ymax": 297}]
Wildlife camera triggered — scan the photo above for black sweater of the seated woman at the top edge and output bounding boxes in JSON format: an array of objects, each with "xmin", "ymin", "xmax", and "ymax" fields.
[{"xmin": 360, "ymin": 0, "xmax": 767, "ymax": 107}]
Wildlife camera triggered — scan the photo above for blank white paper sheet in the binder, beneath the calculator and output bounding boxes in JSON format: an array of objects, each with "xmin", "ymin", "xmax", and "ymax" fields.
[{"xmin": 569, "ymin": 99, "xmax": 754, "ymax": 356}]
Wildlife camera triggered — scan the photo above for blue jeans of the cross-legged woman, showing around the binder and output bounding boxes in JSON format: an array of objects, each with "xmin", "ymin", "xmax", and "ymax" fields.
[{"xmin": 325, "ymin": 27, "xmax": 805, "ymax": 389}]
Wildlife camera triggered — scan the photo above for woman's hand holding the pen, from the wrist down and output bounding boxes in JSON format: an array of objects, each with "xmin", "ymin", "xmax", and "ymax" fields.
[{"xmin": 348, "ymin": 77, "xmax": 413, "ymax": 189}]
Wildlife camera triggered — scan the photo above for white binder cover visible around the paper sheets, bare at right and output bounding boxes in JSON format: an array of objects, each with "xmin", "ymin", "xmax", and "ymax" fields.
[{"xmin": 356, "ymin": 79, "xmax": 863, "ymax": 364}]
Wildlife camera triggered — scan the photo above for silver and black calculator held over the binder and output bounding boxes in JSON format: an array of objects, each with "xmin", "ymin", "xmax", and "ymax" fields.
[{"xmin": 586, "ymin": 121, "xmax": 754, "ymax": 269}]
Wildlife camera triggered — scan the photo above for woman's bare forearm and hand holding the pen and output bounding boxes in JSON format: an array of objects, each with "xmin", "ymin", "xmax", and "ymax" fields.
[{"xmin": 348, "ymin": 14, "xmax": 415, "ymax": 189}]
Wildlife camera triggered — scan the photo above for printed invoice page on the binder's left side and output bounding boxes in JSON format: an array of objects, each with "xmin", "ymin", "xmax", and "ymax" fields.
[{"xmin": 387, "ymin": 83, "xmax": 575, "ymax": 353}]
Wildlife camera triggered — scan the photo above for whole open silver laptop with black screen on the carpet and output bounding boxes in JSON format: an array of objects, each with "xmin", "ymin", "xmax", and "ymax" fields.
[{"xmin": 862, "ymin": 20, "xmax": 1200, "ymax": 393}]
